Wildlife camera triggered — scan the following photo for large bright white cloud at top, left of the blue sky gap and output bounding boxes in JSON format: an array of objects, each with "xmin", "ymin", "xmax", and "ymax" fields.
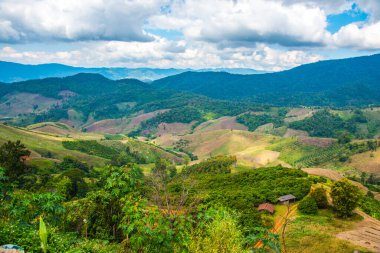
[{"xmin": 149, "ymin": 0, "xmax": 329, "ymax": 46}]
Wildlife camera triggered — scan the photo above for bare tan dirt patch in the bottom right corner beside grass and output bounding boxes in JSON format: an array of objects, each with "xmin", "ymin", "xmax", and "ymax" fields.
[{"xmin": 336, "ymin": 210, "xmax": 380, "ymax": 252}]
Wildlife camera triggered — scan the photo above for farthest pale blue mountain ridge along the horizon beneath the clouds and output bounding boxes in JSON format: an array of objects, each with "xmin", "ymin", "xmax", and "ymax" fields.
[{"xmin": 0, "ymin": 61, "xmax": 262, "ymax": 83}]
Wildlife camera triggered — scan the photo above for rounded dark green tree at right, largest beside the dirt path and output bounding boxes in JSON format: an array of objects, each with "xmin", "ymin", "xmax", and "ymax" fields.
[{"xmin": 331, "ymin": 178, "xmax": 361, "ymax": 218}]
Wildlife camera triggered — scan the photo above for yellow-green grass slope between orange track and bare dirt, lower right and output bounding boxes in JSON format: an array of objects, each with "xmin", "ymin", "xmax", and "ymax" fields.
[{"xmin": 286, "ymin": 210, "xmax": 370, "ymax": 253}]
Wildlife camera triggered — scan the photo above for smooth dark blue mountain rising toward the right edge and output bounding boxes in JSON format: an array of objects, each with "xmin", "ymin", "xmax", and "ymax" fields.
[{"xmin": 153, "ymin": 54, "xmax": 380, "ymax": 106}]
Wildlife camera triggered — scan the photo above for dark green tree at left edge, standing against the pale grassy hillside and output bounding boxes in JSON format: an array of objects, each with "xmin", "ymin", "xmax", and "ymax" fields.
[{"xmin": 0, "ymin": 141, "xmax": 30, "ymax": 180}]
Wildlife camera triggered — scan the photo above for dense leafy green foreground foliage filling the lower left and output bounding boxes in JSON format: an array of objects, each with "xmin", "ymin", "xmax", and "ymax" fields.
[{"xmin": 0, "ymin": 143, "xmax": 290, "ymax": 253}]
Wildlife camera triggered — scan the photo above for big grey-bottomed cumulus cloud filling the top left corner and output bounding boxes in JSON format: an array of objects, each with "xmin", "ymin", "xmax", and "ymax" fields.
[{"xmin": 0, "ymin": 0, "xmax": 162, "ymax": 42}]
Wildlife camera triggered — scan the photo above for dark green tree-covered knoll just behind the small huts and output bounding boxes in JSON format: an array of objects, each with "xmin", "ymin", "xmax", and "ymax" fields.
[{"xmin": 175, "ymin": 166, "xmax": 311, "ymax": 235}]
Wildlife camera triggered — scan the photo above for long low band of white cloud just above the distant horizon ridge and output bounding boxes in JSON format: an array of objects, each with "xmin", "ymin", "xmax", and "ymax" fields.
[{"xmin": 0, "ymin": 38, "xmax": 322, "ymax": 71}]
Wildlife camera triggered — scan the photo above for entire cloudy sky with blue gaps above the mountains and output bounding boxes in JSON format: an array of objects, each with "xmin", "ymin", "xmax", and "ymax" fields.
[{"xmin": 0, "ymin": 0, "xmax": 380, "ymax": 71}]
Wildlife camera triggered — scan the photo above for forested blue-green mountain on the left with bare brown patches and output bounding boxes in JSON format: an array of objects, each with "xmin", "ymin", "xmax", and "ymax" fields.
[{"xmin": 0, "ymin": 73, "xmax": 261, "ymax": 130}]
